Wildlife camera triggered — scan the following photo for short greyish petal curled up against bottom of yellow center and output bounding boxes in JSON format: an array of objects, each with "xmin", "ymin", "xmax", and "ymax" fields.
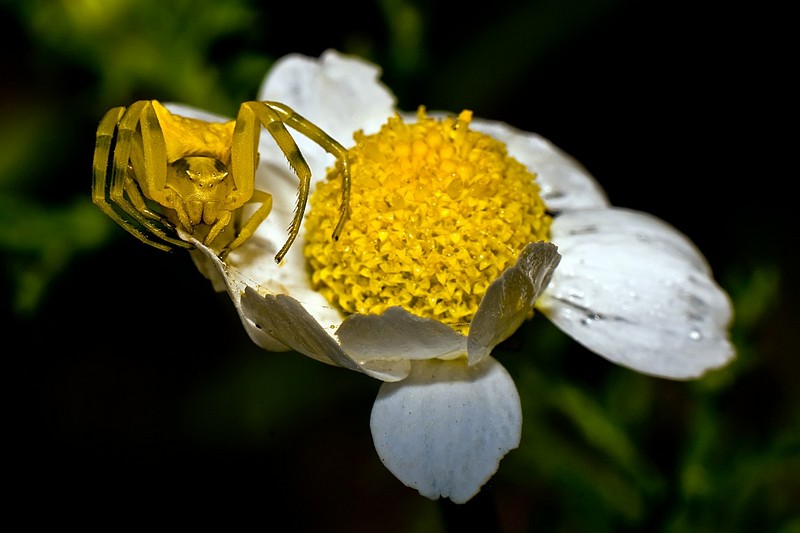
[{"xmin": 336, "ymin": 307, "xmax": 467, "ymax": 360}]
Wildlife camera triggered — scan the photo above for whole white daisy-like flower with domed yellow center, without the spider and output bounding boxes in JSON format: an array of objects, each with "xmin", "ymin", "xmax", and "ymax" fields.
[{"xmin": 178, "ymin": 51, "xmax": 734, "ymax": 502}]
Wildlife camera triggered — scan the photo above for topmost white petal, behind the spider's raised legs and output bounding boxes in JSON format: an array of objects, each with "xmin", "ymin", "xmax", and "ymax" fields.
[{"xmin": 258, "ymin": 50, "xmax": 396, "ymax": 177}]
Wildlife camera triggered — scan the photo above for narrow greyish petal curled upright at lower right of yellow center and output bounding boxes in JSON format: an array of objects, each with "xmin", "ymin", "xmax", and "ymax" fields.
[{"xmin": 467, "ymin": 242, "xmax": 561, "ymax": 365}]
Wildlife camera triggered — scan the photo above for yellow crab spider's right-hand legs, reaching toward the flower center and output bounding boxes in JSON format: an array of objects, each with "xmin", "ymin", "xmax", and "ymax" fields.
[{"xmin": 229, "ymin": 102, "xmax": 350, "ymax": 263}]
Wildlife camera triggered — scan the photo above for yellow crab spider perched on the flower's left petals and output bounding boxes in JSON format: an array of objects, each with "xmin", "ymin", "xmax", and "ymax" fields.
[{"xmin": 92, "ymin": 100, "xmax": 350, "ymax": 263}]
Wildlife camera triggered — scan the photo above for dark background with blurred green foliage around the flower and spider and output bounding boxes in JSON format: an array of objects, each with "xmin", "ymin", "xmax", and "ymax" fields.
[{"xmin": 0, "ymin": 0, "xmax": 800, "ymax": 532}]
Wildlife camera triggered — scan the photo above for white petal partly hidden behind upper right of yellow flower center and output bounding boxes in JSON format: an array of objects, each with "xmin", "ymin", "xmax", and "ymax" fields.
[{"xmin": 472, "ymin": 119, "xmax": 609, "ymax": 211}]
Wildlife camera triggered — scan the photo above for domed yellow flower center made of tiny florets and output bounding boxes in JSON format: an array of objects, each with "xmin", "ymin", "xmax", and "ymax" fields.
[{"xmin": 304, "ymin": 107, "xmax": 552, "ymax": 333}]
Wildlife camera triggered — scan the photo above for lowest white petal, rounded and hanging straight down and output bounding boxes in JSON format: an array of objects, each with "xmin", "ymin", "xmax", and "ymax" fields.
[{"xmin": 370, "ymin": 357, "xmax": 522, "ymax": 503}]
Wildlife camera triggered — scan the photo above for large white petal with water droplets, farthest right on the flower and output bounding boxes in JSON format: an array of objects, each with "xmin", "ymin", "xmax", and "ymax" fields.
[{"xmin": 537, "ymin": 209, "xmax": 734, "ymax": 379}]
